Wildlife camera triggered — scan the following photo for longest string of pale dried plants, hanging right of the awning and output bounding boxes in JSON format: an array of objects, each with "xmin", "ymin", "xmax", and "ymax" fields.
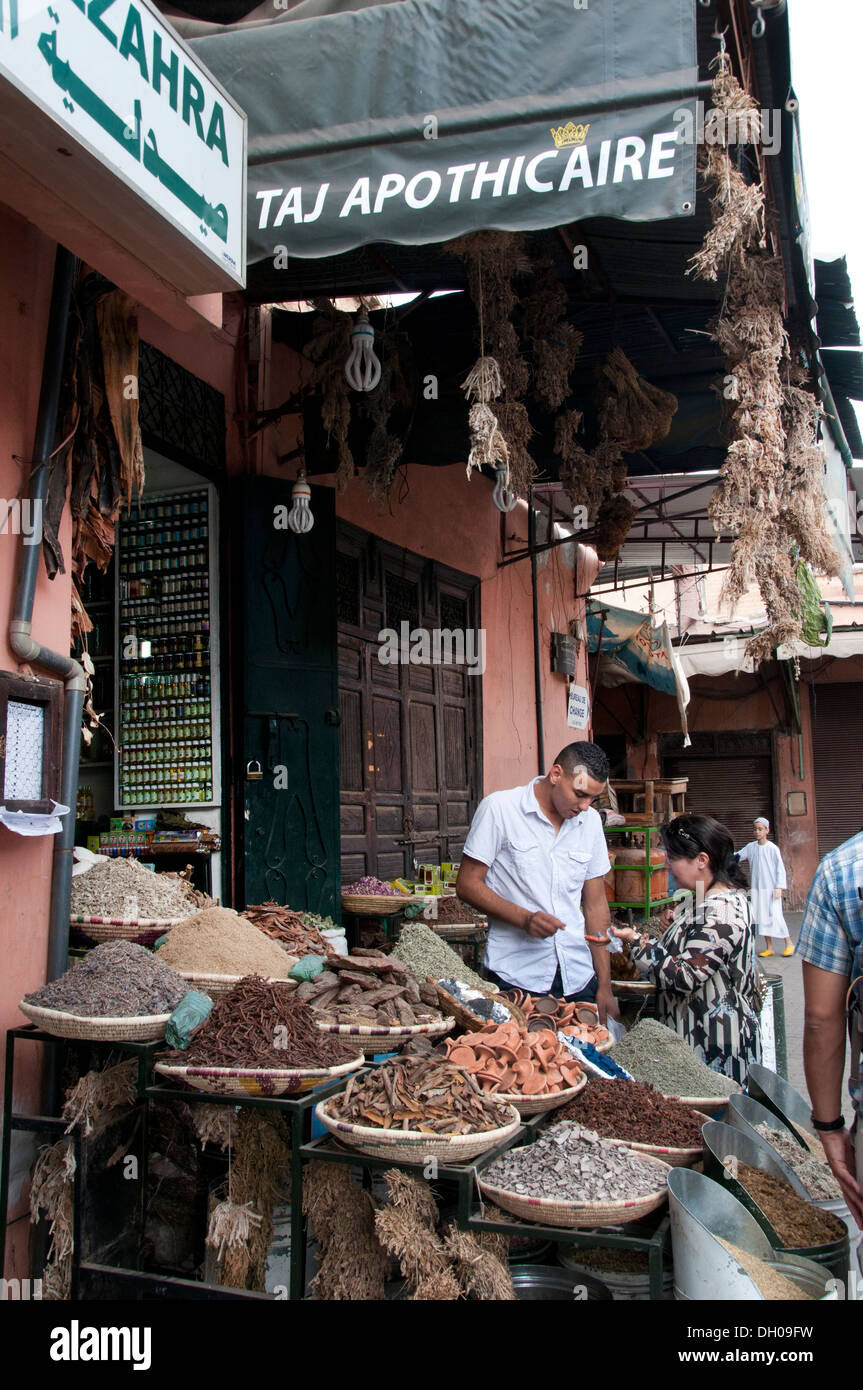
[{"xmin": 688, "ymin": 40, "xmax": 838, "ymax": 664}]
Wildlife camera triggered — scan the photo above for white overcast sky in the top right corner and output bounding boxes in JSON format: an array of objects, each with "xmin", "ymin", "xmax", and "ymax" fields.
[{"xmin": 789, "ymin": 0, "xmax": 863, "ymax": 447}]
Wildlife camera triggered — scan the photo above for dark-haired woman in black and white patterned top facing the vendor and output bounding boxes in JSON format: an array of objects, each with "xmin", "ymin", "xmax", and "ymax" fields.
[{"xmin": 611, "ymin": 816, "xmax": 760, "ymax": 1084}]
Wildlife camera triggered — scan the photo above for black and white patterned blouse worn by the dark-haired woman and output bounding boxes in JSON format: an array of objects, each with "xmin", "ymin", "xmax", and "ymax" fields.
[{"xmin": 632, "ymin": 890, "xmax": 762, "ymax": 1086}]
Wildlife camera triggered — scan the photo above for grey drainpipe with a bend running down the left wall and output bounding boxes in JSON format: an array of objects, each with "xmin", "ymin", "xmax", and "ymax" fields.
[{"xmin": 10, "ymin": 246, "xmax": 86, "ymax": 989}]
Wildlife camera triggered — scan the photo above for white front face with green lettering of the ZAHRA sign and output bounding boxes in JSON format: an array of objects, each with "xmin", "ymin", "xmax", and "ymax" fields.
[{"xmin": 0, "ymin": 0, "xmax": 246, "ymax": 288}]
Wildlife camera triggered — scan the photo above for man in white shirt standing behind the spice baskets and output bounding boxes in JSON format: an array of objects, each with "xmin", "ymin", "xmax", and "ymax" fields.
[{"xmin": 456, "ymin": 742, "xmax": 618, "ymax": 1023}]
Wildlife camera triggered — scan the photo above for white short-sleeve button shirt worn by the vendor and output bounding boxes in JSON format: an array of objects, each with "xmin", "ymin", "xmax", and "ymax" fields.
[{"xmin": 464, "ymin": 777, "xmax": 611, "ymax": 994}]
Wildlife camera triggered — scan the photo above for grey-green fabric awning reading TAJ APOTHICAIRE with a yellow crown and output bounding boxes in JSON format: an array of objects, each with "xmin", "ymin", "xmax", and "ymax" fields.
[{"xmin": 183, "ymin": 0, "xmax": 698, "ymax": 268}]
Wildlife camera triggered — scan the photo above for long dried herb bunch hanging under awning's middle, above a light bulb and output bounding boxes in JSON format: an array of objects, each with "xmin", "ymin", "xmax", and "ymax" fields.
[{"xmin": 446, "ymin": 232, "xmax": 536, "ymax": 496}]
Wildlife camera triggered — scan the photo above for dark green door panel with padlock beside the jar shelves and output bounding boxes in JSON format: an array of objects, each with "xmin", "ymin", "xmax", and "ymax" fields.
[{"xmin": 235, "ymin": 478, "xmax": 340, "ymax": 920}]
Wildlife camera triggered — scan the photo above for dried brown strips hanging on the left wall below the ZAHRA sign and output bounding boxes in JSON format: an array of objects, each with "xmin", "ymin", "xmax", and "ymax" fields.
[{"xmin": 42, "ymin": 267, "xmax": 145, "ymax": 637}]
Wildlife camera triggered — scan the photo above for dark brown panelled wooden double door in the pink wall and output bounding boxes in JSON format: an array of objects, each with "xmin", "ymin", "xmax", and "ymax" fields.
[{"xmin": 336, "ymin": 527, "xmax": 482, "ymax": 881}]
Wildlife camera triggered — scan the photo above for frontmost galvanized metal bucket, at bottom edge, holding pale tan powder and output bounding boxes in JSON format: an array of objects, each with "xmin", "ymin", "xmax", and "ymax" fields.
[{"xmin": 668, "ymin": 1168, "xmax": 838, "ymax": 1302}]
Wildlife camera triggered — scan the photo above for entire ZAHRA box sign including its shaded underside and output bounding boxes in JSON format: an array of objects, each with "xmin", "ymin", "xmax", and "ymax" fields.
[{"xmin": 0, "ymin": 0, "xmax": 246, "ymax": 293}]
